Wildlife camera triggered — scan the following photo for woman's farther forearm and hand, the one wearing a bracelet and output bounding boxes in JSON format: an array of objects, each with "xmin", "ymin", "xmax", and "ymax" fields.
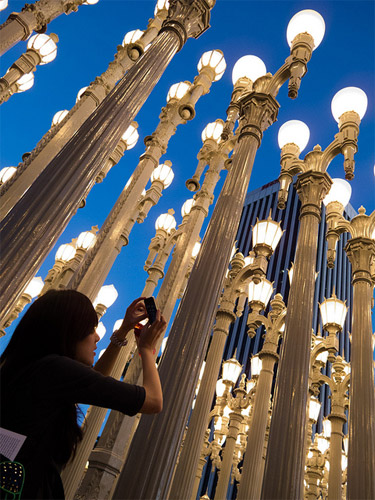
[{"xmin": 94, "ymin": 297, "xmax": 147, "ymax": 375}]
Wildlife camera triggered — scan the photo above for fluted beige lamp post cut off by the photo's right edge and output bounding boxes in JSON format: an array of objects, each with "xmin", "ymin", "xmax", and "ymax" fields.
[{"xmin": 327, "ymin": 193, "xmax": 375, "ymax": 500}]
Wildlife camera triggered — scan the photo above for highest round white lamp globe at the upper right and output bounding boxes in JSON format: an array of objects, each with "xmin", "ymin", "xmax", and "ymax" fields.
[{"xmin": 286, "ymin": 9, "xmax": 326, "ymax": 50}]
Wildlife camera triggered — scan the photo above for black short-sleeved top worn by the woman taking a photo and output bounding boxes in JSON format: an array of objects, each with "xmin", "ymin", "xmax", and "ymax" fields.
[{"xmin": 1, "ymin": 355, "xmax": 146, "ymax": 500}]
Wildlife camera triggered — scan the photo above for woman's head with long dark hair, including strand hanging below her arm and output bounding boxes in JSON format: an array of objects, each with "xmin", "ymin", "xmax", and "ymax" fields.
[{"xmin": 0, "ymin": 290, "xmax": 98, "ymax": 461}]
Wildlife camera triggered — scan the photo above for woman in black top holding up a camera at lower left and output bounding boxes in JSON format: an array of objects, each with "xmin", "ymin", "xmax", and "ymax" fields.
[{"xmin": 0, "ymin": 290, "xmax": 166, "ymax": 500}]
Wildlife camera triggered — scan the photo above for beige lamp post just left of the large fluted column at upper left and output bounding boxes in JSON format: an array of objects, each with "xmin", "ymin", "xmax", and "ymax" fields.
[{"xmin": 0, "ymin": 0, "xmax": 169, "ymax": 219}]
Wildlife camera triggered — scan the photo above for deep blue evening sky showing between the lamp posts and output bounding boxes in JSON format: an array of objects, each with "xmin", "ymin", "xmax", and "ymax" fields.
[{"xmin": 0, "ymin": 0, "xmax": 375, "ymax": 360}]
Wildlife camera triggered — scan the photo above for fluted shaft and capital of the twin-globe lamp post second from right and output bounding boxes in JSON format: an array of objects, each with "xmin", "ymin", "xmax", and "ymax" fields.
[{"xmin": 262, "ymin": 170, "xmax": 332, "ymax": 500}]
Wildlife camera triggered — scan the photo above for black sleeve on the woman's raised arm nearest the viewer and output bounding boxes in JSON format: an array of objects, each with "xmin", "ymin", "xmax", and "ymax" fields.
[{"xmin": 35, "ymin": 356, "xmax": 146, "ymax": 416}]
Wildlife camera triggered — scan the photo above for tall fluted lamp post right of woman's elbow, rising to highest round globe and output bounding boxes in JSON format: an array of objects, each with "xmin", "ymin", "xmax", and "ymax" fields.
[{"xmin": 122, "ymin": 10, "xmax": 322, "ymax": 498}]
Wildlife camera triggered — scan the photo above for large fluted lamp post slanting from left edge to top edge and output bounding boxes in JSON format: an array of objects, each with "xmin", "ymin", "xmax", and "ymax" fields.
[{"xmin": 0, "ymin": 0, "xmax": 214, "ymax": 313}]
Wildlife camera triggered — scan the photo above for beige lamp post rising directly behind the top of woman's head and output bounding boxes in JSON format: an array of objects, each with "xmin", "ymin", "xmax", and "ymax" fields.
[{"xmin": 65, "ymin": 51, "xmax": 225, "ymax": 302}]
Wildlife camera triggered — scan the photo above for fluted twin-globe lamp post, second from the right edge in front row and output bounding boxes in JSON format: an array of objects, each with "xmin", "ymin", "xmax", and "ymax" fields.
[{"xmin": 262, "ymin": 84, "xmax": 365, "ymax": 499}]
